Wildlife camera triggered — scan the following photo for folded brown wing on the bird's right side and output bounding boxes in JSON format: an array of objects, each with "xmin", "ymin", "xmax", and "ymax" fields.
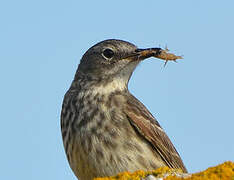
[{"xmin": 124, "ymin": 95, "xmax": 187, "ymax": 172}]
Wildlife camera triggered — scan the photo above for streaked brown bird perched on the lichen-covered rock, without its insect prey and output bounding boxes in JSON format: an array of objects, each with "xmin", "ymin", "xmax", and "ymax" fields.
[{"xmin": 61, "ymin": 39, "xmax": 187, "ymax": 180}]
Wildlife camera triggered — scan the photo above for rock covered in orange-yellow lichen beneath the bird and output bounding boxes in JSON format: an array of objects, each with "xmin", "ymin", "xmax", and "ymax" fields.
[{"xmin": 94, "ymin": 161, "xmax": 234, "ymax": 180}]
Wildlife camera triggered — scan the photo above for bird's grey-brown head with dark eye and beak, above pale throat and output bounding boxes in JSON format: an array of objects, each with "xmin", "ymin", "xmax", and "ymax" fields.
[{"xmin": 77, "ymin": 39, "xmax": 160, "ymax": 82}]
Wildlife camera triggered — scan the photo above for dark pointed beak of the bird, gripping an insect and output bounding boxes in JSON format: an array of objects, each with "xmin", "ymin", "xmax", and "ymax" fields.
[{"xmin": 124, "ymin": 48, "xmax": 162, "ymax": 61}]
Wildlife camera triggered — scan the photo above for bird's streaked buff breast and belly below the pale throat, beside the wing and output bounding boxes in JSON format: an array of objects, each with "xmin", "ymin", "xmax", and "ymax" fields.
[{"xmin": 63, "ymin": 91, "xmax": 164, "ymax": 179}]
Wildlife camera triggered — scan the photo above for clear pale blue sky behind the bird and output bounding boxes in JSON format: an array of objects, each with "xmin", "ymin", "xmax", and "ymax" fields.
[{"xmin": 0, "ymin": 0, "xmax": 234, "ymax": 180}]
